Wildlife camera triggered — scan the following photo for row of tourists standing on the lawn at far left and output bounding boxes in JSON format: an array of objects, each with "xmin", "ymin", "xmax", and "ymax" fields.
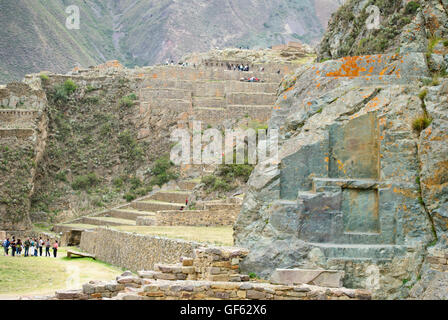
[{"xmin": 2, "ymin": 237, "xmax": 59, "ymax": 258}]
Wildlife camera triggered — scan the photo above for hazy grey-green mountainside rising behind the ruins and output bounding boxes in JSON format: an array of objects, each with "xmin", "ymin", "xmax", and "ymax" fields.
[{"xmin": 0, "ymin": 0, "xmax": 341, "ymax": 82}]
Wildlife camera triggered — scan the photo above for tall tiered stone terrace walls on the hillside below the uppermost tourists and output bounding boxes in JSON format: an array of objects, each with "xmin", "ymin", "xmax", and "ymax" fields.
[{"xmin": 135, "ymin": 66, "xmax": 282, "ymax": 125}]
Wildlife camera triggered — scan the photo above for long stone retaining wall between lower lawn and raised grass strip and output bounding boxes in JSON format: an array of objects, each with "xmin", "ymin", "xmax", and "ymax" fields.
[{"xmin": 80, "ymin": 228, "xmax": 203, "ymax": 271}]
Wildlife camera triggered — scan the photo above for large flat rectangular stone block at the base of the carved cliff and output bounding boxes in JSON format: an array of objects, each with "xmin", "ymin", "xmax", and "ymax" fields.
[{"xmin": 271, "ymin": 269, "xmax": 344, "ymax": 288}]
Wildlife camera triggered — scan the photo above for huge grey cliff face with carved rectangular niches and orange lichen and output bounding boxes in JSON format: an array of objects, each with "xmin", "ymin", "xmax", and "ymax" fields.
[{"xmin": 234, "ymin": 1, "xmax": 448, "ymax": 298}]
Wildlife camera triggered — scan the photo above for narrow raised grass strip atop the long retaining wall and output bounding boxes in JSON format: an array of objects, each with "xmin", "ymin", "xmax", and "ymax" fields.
[{"xmin": 112, "ymin": 226, "xmax": 233, "ymax": 246}]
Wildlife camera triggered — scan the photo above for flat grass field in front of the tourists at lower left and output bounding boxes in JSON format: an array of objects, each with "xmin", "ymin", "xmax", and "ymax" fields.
[{"xmin": 0, "ymin": 248, "xmax": 123, "ymax": 299}]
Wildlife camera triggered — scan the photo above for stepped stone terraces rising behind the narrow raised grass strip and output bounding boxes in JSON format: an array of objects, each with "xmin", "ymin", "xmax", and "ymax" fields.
[{"xmin": 55, "ymin": 180, "xmax": 242, "ymax": 232}]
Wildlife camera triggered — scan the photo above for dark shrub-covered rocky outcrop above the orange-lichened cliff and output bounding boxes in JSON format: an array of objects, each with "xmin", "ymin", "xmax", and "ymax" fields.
[{"xmin": 318, "ymin": 0, "xmax": 448, "ymax": 60}]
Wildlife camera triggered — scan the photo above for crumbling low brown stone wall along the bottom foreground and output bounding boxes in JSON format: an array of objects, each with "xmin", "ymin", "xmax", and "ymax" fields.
[{"xmin": 44, "ymin": 246, "xmax": 371, "ymax": 300}]
